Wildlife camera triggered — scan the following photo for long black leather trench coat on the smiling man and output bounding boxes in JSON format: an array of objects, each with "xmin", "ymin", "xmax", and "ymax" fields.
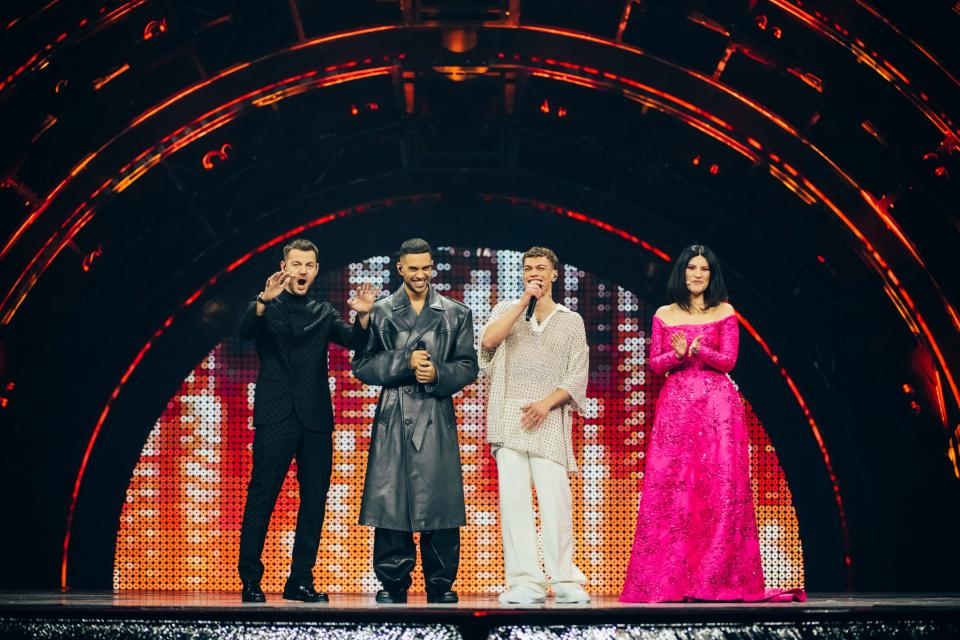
[{"xmin": 353, "ymin": 286, "xmax": 479, "ymax": 531}]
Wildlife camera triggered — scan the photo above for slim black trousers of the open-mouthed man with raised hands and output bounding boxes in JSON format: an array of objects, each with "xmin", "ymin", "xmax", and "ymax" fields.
[{"xmin": 237, "ymin": 414, "xmax": 333, "ymax": 586}]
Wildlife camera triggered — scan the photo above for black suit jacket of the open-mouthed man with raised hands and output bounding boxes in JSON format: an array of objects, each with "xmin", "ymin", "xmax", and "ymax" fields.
[{"xmin": 240, "ymin": 292, "xmax": 367, "ymax": 431}]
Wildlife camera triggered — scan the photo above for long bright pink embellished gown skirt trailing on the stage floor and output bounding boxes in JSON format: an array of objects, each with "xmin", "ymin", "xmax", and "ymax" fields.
[{"xmin": 620, "ymin": 368, "xmax": 806, "ymax": 602}]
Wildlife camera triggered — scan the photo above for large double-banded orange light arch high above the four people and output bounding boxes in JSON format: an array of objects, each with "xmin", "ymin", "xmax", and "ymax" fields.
[{"xmin": 0, "ymin": 25, "xmax": 960, "ymax": 422}]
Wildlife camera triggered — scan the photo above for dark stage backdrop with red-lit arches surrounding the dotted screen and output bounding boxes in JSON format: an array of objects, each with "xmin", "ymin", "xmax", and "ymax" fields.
[{"xmin": 0, "ymin": 0, "xmax": 960, "ymax": 591}]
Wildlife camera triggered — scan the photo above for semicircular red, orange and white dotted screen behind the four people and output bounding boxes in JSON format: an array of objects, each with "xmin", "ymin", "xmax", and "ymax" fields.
[{"xmin": 114, "ymin": 248, "xmax": 803, "ymax": 595}]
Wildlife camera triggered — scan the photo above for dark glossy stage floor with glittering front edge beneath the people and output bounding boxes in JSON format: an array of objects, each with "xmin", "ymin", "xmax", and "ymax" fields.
[{"xmin": 0, "ymin": 592, "xmax": 960, "ymax": 640}]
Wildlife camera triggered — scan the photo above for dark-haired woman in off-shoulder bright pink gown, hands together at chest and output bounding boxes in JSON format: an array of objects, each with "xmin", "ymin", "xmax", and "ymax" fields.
[{"xmin": 620, "ymin": 245, "xmax": 804, "ymax": 602}]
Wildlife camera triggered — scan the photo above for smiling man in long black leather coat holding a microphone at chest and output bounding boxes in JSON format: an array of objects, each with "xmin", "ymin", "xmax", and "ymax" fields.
[{"xmin": 353, "ymin": 238, "xmax": 478, "ymax": 603}]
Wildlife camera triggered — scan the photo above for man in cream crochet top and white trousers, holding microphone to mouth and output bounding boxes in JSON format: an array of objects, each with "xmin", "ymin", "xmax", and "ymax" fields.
[{"xmin": 480, "ymin": 247, "xmax": 590, "ymax": 604}]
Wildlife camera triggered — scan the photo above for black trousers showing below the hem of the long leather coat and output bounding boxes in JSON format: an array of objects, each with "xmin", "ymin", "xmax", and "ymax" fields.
[{"xmin": 373, "ymin": 527, "xmax": 460, "ymax": 592}]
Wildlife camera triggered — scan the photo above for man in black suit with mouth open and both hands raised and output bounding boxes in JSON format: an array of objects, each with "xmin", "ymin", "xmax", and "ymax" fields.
[{"xmin": 237, "ymin": 239, "xmax": 376, "ymax": 602}]
